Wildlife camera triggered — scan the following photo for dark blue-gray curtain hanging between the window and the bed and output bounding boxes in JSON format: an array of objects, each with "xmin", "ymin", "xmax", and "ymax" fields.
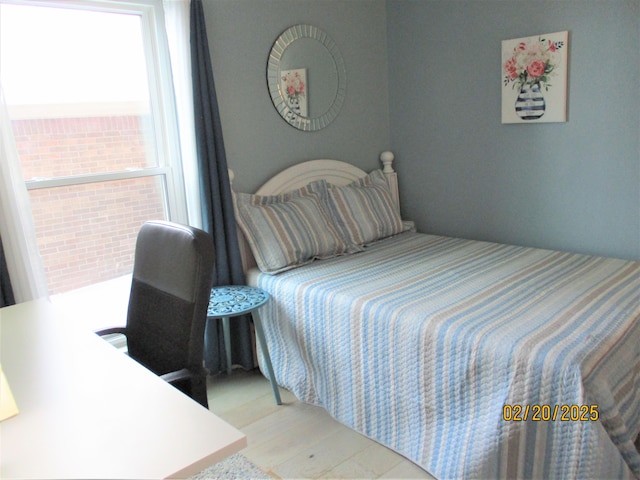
[{"xmin": 190, "ymin": 0, "xmax": 254, "ymax": 374}]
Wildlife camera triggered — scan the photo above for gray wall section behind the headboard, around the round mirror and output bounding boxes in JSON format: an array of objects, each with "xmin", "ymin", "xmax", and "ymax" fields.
[{"xmin": 203, "ymin": 0, "xmax": 390, "ymax": 192}]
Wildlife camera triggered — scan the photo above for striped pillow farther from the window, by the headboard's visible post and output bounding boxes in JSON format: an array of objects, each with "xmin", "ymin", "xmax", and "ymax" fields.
[{"xmin": 329, "ymin": 170, "xmax": 405, "ymax": 248}]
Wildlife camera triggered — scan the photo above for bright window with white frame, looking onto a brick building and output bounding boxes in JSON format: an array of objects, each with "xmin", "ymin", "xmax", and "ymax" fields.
[{"xmin": 0, "ymin": 0, "xmax": 187, "ymax": 294}]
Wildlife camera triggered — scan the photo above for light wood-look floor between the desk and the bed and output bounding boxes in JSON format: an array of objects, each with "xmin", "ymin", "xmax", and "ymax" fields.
[{"xmin": 208, "ymin": 370, "xmax": 433, "ymax": 479}]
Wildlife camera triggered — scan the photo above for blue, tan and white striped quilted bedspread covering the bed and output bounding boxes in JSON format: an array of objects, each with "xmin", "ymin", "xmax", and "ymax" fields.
[{"xmin": 256, "ymin": 233, "xmax": 640, "ymax": 479}]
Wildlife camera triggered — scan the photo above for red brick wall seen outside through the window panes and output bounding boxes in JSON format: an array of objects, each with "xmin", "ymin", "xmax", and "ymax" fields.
[{"xmin": 13, "ymin": 115, "xmax": 165, "ymax": 294}]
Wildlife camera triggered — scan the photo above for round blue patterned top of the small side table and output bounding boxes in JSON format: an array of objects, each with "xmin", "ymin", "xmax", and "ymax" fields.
[{"xmin": 207, "ymin": 285, "xmax": 269, "ymax": 318}]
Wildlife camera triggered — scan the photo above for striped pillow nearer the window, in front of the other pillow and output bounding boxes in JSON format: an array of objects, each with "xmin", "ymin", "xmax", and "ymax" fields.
[{"xmin": 235, "ymin": 180, "xmax": 347, "ymax": 273}]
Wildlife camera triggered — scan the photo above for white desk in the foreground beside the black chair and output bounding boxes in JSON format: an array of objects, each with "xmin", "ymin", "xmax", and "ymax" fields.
[{"xmin": 0, "ymin": 301, "xmax": 247, "ymax": 479}]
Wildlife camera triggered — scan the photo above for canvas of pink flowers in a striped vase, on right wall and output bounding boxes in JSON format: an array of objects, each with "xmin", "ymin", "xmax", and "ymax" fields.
[{"xmin": 502, "ymin": 31, "xmax": 569, "ymax": 123}]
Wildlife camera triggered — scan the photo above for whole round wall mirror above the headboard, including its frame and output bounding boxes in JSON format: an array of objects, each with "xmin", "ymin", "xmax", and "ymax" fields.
[{"xmin": 267, "ymin": 25, "xmax": 347, "ymax": 131}]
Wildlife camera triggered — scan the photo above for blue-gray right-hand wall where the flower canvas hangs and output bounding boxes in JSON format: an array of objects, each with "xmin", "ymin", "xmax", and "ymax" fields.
[{"xmin": 387, "ymin": 0, "xmax": 640, "ymax": 259}]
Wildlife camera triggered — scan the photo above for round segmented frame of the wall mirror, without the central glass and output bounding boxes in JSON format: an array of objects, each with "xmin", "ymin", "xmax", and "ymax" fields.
[{"xmin": 267, "ymin": 25, "xmax": 347, "ymax": 131}]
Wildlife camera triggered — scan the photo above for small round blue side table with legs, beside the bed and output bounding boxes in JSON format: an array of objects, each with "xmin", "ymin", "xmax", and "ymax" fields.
[{"xmin": 207, "ymin": 285, "xmax": 282, "ymax": 405}]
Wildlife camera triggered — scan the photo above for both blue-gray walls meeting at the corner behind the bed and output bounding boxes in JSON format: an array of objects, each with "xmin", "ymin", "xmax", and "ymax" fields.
[{"xmin": 204, "ymin": 0, "xmax": 640, "ymax": 259}]
